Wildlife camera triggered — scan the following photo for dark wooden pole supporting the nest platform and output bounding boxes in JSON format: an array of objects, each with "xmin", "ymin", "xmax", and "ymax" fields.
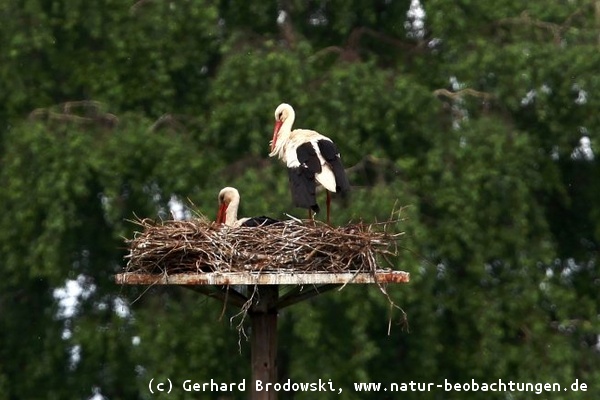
[{"xmin": 248, "ymin": 285, "xmax": 279, "ymax": 400}]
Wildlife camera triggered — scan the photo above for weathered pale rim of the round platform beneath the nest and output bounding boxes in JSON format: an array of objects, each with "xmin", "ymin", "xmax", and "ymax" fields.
[{"xmin": 115, "ymin": 270, "xmax": 410, "ymax": 285}]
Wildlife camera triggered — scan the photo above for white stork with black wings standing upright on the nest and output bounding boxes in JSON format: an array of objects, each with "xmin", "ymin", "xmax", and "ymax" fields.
[{"xmin": 269, "ymin": 103, "xmax": 350, "ymax": 224}]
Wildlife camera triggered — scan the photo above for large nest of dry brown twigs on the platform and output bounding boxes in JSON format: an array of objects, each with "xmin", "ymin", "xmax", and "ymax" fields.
[{"xmin": 125, "ymin": 218, "xmax": 403, "ymax": 275}]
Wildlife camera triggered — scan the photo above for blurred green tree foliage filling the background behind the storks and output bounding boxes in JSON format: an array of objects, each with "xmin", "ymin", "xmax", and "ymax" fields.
[{"xmin": 0, "ymin": 0, "xmax": 600, "ymax": 399}]
